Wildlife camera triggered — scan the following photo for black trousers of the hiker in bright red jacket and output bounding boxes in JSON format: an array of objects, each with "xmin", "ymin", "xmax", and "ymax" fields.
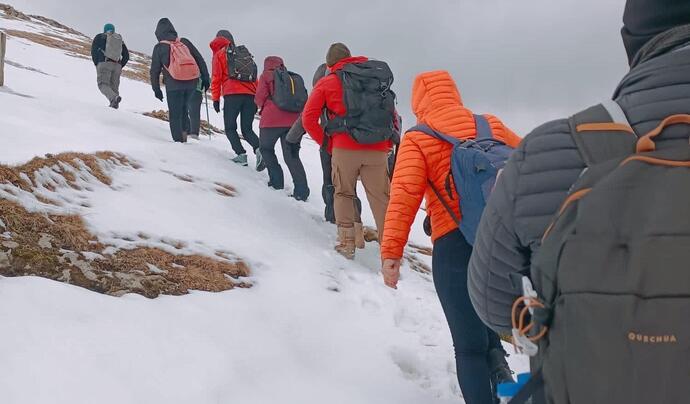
[{"xmin": 223, "ymin": 94, "xmax": 259, "ymax": 155}]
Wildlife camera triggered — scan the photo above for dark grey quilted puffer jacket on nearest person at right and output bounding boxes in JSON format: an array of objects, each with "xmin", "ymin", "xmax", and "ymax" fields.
[{"xmin": 469, "ymin": 27, "xmax": 690, "ymax": 333}]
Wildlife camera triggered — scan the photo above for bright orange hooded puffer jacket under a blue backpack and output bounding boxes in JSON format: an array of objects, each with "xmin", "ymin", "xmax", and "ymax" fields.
[{"xmin": 381, "ymin": 71, "xmax": 521, "ymax": 259}]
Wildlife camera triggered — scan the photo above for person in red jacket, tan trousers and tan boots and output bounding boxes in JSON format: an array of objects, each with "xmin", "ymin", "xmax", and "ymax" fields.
[{"xmin": 302, "ymin": 43, "xmax": 393, "ymax": 259}]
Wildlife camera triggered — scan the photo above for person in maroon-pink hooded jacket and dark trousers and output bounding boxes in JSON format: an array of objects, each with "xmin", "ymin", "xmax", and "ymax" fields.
[{"xmin": 254, "ymin": 56, "xmax": 309, "ymax": 201}]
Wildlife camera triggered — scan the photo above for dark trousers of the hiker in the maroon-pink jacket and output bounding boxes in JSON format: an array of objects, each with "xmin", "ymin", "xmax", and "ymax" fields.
[{"xmin": 259, "ymin": 128, "xmax": 309, "ymax": 199}]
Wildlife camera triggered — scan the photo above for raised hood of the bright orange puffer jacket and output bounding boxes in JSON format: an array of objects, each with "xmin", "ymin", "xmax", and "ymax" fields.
[{"xmin": 412, "ymin": 70, "xmax": 462, "ymax": 122}]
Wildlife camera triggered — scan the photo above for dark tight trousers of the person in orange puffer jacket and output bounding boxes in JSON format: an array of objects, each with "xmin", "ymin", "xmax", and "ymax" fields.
[{"xmin": 432, "ymin": 230, "xmax": 503, "ymax": 404}]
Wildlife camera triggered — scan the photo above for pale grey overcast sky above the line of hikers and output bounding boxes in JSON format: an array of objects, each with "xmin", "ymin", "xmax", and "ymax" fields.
[{"xmin": 10, "ymin": 0, "xmax": 627, "ymax": 135}]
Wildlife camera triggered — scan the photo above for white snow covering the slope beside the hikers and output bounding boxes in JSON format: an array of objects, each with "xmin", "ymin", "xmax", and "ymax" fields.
[{"xmin": 0, "ymin": 13, "xmax": 526, "ymax": 404}]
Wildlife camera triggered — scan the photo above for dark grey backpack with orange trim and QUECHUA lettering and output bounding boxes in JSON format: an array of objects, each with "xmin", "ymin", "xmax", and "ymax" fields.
[{"xmin": 511, "ymin": 102, "xmax": 690, "ymax": 404}]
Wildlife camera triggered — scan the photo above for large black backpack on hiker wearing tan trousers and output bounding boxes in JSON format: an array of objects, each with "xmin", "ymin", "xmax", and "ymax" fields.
[{"xmin": 326, "ymin": 60, "xmax": 395, "ymax": 144}]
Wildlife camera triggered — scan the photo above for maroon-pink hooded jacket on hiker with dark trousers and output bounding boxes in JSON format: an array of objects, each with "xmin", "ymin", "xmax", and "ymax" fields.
[{"xmin": 254, "ymin": 56, "xmax": 299, "ymax": 128}]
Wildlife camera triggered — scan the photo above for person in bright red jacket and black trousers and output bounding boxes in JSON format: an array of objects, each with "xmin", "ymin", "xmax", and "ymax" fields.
[{"xmin": 210, "ymin": 30, "xmax": 265, "ymax": 171}]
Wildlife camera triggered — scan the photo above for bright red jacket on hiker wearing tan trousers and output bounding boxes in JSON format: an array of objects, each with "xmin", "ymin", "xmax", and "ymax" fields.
[{"xmin": 302, "ymin": 56, "xmax": 393, "ymax": 152}]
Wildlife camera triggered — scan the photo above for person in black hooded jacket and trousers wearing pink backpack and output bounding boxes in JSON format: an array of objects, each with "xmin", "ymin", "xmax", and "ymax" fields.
[{"xmin": 151, "ymin": 18, "xmax": 211, "ymax": 143}]
